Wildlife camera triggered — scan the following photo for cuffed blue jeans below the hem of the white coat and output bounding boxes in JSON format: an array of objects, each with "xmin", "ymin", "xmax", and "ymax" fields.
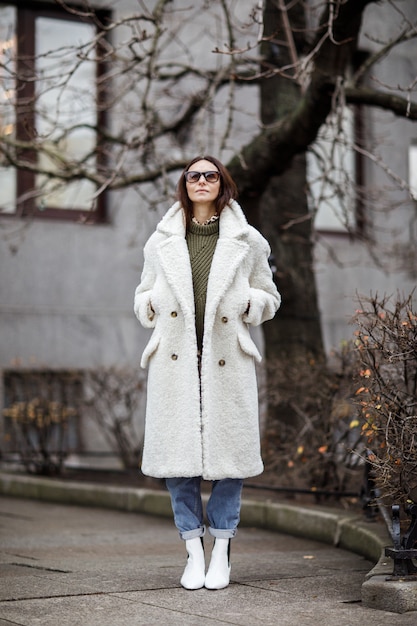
[{"xmin": 166, "ymin": 476, "xmax": 243, "ymax": 540}]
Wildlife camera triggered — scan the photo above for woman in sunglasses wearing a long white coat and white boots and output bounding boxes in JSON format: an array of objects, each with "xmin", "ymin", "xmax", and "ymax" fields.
[{"xmin": 134, "ymin": 156, "xmax": 280, "ymax": 589}]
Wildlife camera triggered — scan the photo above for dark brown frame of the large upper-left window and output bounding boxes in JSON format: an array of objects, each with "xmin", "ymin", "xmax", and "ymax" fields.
[{"xmin": 0, "ymin": 0, "xmax": 111, "ymax": 224}]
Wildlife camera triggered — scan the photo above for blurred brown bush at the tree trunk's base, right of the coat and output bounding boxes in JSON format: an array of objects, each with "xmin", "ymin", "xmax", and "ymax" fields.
[{"xmin": 263, "ymin": 344, "xmax": 363, "ymax": 493}]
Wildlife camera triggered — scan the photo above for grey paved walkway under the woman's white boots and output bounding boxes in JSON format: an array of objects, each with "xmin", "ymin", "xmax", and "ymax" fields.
[{"xmin": 0, "ymin": 497, "xmax": 417, "ymax": 626}]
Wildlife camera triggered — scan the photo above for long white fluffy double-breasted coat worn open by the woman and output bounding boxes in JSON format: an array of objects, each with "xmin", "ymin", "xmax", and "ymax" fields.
[{"xmin": 134, "ymin": 201, "xmax": 281, "ymax": 480}]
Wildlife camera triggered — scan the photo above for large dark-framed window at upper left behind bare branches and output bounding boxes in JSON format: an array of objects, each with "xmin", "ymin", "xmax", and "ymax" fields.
[{"xmin": 0, "ymin": 2, "xmax": 107, "ymax": 221}]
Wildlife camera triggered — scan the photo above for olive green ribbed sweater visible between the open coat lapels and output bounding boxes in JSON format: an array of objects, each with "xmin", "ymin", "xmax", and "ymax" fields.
[{"xmin": 186, "ymin": 220, "xmax": 219, "ymax": 350}]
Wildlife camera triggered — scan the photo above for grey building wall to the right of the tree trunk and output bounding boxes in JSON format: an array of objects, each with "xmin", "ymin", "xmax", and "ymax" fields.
[{"xmin": 316, "ymin": 2, "xmax": 417, "ymax": 350}]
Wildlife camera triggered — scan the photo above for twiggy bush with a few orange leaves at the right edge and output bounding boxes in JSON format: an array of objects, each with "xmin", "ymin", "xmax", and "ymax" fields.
[{"xmin": 354, "ymin": 294, "xmax": 417, "ymax": 504}]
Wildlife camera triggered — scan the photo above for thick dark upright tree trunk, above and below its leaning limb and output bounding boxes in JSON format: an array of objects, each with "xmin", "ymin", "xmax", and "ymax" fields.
[{"xmin": 250, "ymin": 0, "xmax": 324, "ymax": 428}]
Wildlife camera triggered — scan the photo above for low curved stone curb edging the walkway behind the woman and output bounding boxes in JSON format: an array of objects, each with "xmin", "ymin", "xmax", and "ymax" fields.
[{"xmin": 0, "ymin": 472, "xmax": 417, "ymax": 613}]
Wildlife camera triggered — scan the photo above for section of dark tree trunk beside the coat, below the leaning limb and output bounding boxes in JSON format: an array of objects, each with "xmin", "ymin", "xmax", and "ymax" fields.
[{"xmin": 260, "ymin": 155, "xmax": 324, "ymax": 363}]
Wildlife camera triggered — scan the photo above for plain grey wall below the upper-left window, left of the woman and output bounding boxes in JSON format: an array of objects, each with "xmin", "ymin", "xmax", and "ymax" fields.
[{"xmin": 0, "ymin": 188, "xmax": 156, "ymax": 368}]
